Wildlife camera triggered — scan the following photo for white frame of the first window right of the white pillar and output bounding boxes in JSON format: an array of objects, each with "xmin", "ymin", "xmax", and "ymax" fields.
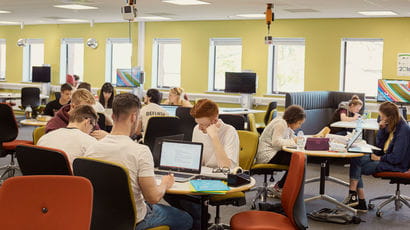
[{"xmin": 151, "ymin": 38, "xmax": 182, "ymax": 89}]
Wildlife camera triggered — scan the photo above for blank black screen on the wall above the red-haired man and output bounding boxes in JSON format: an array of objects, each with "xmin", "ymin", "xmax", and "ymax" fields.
[{"xmin": 225, "ymin": 72, "xmax": 256, "ymax": 94}]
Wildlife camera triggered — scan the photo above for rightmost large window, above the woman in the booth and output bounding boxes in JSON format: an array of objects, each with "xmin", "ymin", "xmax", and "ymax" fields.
[{"xmin": 340, "ymin": 38, "xmax": 383, "ymax": 97}]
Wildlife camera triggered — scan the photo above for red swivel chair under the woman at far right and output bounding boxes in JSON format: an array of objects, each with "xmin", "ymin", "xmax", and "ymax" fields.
[{"xmin": 369, "ymin": 170, "xmax": 410, "ymax": 217}]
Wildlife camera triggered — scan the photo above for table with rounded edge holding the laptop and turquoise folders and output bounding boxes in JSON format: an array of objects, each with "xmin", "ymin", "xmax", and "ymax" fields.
[{"xmin": 157, "ymin": 177, "xmax": 256, "ymax": 230}]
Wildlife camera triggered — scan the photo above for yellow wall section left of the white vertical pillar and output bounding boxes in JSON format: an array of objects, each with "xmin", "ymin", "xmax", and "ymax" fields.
[{"xmin": 0, "ymin": 23, "xmax": 138, "ymax": 87}]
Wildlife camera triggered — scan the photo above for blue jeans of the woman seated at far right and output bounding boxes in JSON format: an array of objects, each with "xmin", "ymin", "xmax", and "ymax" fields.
[{"xmin": 350, "ymin": 155, "xmax": 379, "ymax": 189}]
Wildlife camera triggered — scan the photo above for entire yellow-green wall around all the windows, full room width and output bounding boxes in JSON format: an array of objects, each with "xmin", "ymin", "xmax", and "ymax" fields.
[{"xmin": 0, "ymin": 18, "xmax": 410, "ymax": 96}]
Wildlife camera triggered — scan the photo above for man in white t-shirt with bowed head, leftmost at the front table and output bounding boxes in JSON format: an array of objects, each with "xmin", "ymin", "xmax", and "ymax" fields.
[{"xmin": 37, "ymin": 105, "xmax": 98, "ymax": 164}]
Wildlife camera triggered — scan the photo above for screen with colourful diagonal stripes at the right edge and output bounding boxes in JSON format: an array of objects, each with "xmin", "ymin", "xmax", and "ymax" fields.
[{"xmin": 377, "ymin": 79, "xmax": 410, "ymax": 104}]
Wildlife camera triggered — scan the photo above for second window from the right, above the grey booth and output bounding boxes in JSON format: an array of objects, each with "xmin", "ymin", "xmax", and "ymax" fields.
[{"xmin": 268, "ymin": 38, "xmax": 305, "ymax": 94}]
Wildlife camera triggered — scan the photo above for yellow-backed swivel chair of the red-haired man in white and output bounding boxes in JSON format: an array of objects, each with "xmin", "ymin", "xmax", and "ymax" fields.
[{"xmin": 209, "ymin": 130, "xmax": 259, "ymax": 229}]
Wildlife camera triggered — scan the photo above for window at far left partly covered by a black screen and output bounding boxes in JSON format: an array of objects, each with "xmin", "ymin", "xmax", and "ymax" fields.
[{"xmin": 23, "ymin": 39, "xmax": 44, "ymax": 82}]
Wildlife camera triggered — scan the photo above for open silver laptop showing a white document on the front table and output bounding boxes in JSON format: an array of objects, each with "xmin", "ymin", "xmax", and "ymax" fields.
[{"xmin": 155, "ymin": 140, "xmax": 203, "ymax": 182}]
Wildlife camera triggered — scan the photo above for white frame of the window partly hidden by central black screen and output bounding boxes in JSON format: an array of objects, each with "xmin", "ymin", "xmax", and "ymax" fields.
[{"xmin": 208, "ymin": 38, "xmax": 243, "ymax": 92}]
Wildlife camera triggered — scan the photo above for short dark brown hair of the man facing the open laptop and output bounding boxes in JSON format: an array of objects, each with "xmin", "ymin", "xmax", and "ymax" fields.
[{"xmin": 112, "ymin": 93, "xmax": 141, "ymax": 120}]
